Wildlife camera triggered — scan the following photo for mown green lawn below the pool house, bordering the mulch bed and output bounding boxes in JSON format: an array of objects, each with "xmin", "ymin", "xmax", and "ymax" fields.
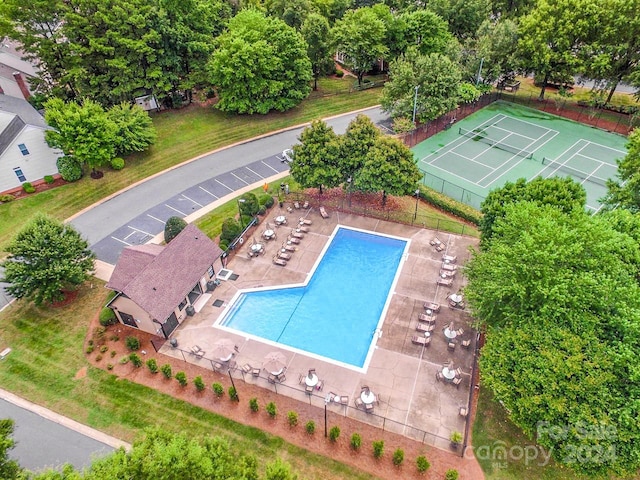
[{"xmin": 0, "ymin": 281, "xmax": 370, "ymax": 479}]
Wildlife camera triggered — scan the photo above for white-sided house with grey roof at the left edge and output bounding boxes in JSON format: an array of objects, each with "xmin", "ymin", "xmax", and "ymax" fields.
[{"xmin": 0, "ymin": 95, "xmax": 62, "ymax": 193}]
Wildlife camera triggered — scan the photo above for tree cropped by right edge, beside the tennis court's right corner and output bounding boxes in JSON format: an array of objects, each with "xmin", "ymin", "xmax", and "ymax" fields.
[{"xmin": 603, "ymin": 129, "xmax": 640, "ymax": 213}]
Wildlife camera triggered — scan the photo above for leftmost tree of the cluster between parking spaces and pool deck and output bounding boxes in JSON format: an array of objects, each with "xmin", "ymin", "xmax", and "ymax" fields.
[{"xmin": 290, "ymin": 120, "xmax": 342, "ymax": 192}]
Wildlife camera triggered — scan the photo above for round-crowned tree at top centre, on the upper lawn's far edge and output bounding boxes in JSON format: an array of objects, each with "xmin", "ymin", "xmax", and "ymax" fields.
[{"xmin": 331, "ymin": 7, "xmax": 387, "ymax": 85}]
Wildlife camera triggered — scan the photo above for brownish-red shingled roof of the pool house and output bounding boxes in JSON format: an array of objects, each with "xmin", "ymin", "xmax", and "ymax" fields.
[{"xmin": 107, "ymin": 225, "xmax": 222, "ymax": 322}]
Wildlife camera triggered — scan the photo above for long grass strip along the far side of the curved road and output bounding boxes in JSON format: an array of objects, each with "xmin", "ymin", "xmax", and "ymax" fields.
[{"xmin": 0, "ymin": 77, "xmax": 382, "ymax": 252}]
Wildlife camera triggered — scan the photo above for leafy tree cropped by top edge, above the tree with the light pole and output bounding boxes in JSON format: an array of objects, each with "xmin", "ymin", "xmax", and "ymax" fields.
[{"xmin": 427, "ymin": 0, "xmax": 491, "ymax": 39}]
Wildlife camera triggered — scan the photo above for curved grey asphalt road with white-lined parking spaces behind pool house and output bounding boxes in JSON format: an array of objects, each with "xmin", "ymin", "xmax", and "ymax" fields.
[{"xmin": 71, "ymin": 107, "xmax": 388, "ymax": 264}]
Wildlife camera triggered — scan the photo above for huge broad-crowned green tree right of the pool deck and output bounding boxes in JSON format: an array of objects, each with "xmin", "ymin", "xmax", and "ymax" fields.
[{"xmin": 465, "ymin": 201, "xmax": 640, "ymax": 475}]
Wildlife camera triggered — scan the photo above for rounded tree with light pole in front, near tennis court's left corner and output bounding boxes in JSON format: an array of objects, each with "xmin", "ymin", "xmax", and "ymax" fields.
[{"xmin": 380, "ymin": 48, "xmax": 462, "ymax": 122}]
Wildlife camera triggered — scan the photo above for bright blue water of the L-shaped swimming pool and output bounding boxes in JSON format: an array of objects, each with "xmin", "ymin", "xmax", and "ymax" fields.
[{"xmin": 222, "ymin": 227, "xmax": 407, "ymax": 367}]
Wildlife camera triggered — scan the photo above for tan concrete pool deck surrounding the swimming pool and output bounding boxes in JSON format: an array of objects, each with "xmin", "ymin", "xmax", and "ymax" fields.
[{"xmin": 161, "ymin": 207, "xmax": 478, "ymax": 448}]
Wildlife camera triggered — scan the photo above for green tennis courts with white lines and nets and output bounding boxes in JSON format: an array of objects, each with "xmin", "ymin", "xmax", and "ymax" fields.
[{"xmin": 412, "ymin": 101, "xmax": 627, "ymax": 211}]
